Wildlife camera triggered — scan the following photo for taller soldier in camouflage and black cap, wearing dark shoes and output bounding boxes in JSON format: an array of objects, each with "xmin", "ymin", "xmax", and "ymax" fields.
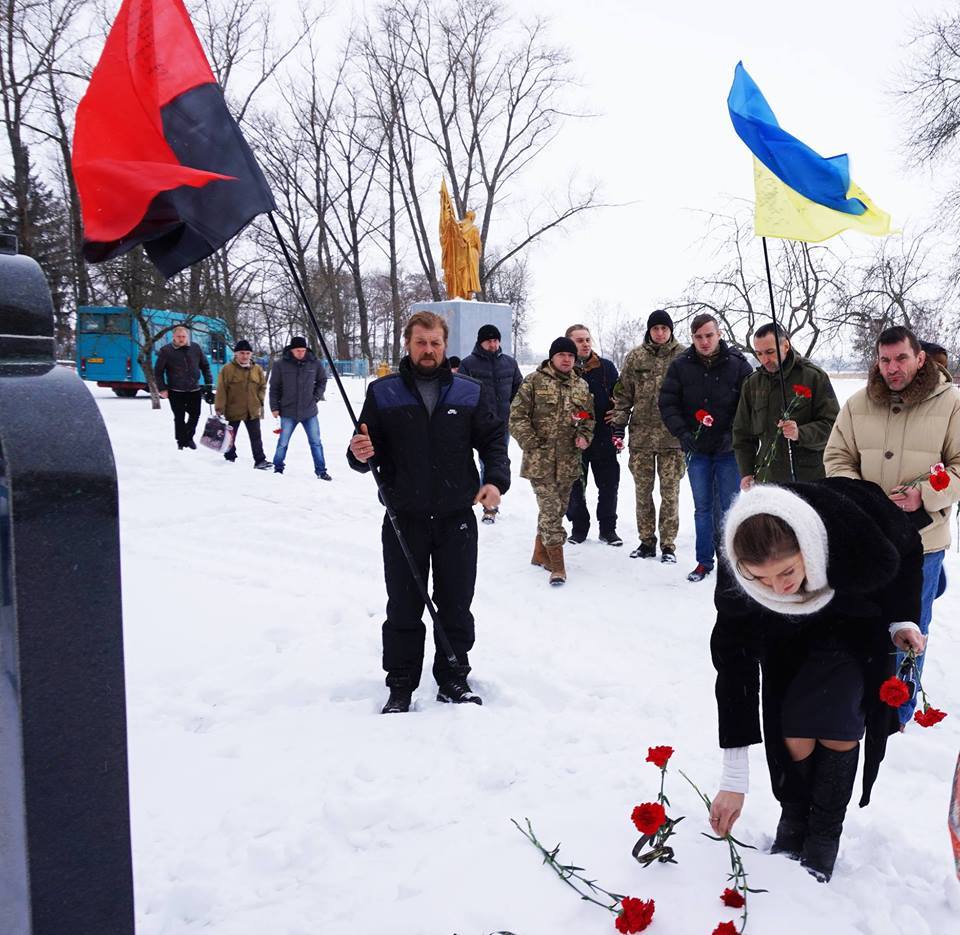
[{"xmin": 613, "ymin": 309, "xmax": 686, "ymax": 562}]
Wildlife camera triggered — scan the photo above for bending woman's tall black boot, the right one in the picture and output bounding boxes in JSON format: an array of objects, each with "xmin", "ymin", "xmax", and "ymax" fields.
[{"xmin": 800, "ymin": 744, "xmax": 860, "ymax": 883}]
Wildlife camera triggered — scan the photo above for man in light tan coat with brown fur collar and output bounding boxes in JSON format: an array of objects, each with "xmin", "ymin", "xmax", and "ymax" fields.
[{"xmin": 823, "ymin": 327, "xmax": 960, "ymax": 725}]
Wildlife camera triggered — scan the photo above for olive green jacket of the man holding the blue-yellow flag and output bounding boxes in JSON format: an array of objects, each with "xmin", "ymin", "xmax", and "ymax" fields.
[{"xmin": 733, "ymin": 349, "xmax": 840, "ymax": 484}]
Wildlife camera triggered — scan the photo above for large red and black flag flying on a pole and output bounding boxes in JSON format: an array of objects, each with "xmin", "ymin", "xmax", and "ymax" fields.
[{"xmin": 73, "ymin": 0, "xmax": 275, "ymax": 278}]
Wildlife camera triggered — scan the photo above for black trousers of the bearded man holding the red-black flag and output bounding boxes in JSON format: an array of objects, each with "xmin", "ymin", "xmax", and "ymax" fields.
[{"xmin": 381, "ymin": 509, "xmax": 477, "ymax": 691}]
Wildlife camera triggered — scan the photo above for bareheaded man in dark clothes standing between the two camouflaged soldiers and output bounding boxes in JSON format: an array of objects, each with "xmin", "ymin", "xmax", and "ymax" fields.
[{"xmin": 566, "ymin": 325, "xmax": 623, "ymax": 545}]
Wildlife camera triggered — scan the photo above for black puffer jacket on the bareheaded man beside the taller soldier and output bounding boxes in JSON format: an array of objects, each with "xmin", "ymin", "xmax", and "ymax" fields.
[{"xmin": 658, "ymin": 341, "xmax": 753, "ymax": 454}]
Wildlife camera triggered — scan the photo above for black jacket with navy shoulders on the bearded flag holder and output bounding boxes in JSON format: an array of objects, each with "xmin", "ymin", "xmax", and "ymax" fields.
[{"xmin": 347, "ymin": 357, "xmax": 510, "ymax": 516}]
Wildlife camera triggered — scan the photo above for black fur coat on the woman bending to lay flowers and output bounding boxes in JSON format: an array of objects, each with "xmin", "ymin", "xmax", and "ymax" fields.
[{"xmin": 710, "ymin": 478, "xmax": 923, "ymax": 806}]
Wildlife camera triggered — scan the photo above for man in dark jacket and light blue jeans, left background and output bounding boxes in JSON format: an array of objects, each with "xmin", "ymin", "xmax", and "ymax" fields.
[{"xmin": 270, "ymin": 337, "xmax": 333, "ymax": 480}]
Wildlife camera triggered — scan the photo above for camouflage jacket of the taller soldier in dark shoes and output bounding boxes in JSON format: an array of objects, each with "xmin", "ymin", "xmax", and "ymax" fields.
[{"xmin": 613, "ymin": 337, "xmax": 684, "ymax": 451}]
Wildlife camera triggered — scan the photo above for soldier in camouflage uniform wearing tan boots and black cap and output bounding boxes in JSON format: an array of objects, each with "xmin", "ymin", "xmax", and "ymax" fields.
[{"xmin": 510, "ymin": 338, "xmax": 596, "ymax": 584}]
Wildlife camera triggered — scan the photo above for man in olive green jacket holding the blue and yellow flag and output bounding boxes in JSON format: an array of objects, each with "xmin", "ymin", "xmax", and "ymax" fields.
[{"xmin": 733, "ymin": 322, "xmax": 840, "ymax": 490}]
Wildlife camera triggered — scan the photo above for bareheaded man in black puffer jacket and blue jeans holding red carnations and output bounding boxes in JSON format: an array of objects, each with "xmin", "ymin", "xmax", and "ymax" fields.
[{"xmin": 659, "ymin": 314, "xmax": 753, "ymax": 581}]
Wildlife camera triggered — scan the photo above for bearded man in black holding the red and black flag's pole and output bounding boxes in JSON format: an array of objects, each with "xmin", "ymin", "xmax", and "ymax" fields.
[{"xmin": 347, "ymin": 312, "xmax": 510, "ymax": 714}]
